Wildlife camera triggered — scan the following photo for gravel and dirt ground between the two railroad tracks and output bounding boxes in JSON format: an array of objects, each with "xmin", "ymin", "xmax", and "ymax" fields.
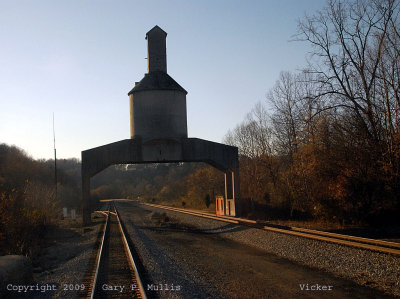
[{"xmin": 117, "ymin": 202, "xmax": 400, "ymax": 298}]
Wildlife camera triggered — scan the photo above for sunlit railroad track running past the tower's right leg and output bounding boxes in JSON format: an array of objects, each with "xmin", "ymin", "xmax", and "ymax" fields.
[{"xmin": 144, "ymin": 203, "xmax": 400, "ymax": 256}]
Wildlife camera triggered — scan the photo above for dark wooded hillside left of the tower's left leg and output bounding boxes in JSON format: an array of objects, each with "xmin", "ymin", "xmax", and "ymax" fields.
[{"xmin": 0, "ymin": 144, "xmax": 80, "ymax": 257}]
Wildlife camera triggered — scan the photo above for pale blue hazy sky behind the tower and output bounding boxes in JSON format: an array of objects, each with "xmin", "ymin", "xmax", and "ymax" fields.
[{"xmin": 0, "ymin": 0, "xmax": 325, "ymax": 159}]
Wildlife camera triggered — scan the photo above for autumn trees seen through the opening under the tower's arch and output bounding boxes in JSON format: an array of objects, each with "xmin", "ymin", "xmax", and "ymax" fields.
[{"xmin": 91, "ymin": 163, "xmax": 225, "ymax": 208}]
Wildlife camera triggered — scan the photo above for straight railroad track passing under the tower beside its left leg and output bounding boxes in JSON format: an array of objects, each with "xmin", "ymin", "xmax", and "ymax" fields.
[{"xmin": 79, "ymin": 203, "xmax": 147, "ymax": 299}]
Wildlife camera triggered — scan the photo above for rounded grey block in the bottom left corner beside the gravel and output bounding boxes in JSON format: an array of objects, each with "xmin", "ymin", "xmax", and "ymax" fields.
[{"xmin": 0, "ymin": 255, "xmax": 33, "ymax": 298}]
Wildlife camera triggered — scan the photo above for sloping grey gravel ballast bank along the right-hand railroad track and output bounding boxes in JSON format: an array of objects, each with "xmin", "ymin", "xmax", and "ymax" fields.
[{"xmin": 141, "ymin": 205, "xmax": 400, "ymax": 296}]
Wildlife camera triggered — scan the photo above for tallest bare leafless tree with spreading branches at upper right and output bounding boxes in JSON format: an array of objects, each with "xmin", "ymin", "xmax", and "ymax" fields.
[{"xmin": 297, "ymin": 0, "xmax": 398, "ymax": 144}]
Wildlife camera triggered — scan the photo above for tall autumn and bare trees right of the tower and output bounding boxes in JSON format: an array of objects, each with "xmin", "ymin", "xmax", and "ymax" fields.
[{"xmin": 225, "ymin": 0, "xmax": 400, "ymax": 224}]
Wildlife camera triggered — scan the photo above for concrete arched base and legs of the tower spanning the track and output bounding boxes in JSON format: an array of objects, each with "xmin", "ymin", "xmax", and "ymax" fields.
[{"xmin": 82, "ymin": 138, "xmax": 240, "ymax": 225}]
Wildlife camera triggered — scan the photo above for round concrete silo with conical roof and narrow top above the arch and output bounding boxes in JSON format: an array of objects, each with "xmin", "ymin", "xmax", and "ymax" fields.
[{"xmin": 128, "ymin": 26, "xmax": 187, "ymax": 142}]
